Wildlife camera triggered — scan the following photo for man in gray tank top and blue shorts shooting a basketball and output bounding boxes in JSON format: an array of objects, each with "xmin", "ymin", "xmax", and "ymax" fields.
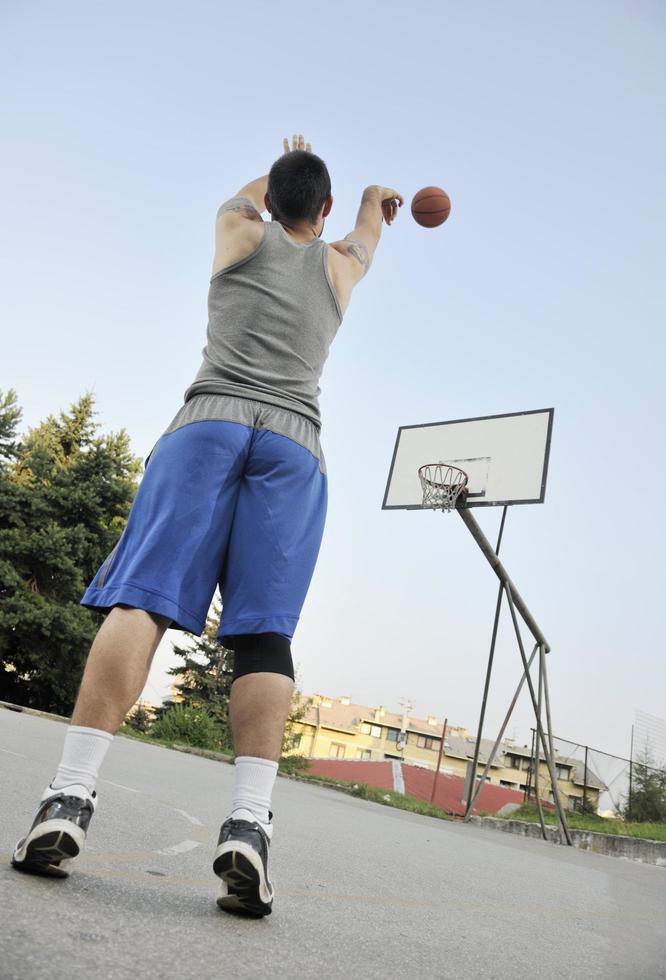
[{"xmin": 12, "ymin": 136, "xmax": 403, "ymax": 916}]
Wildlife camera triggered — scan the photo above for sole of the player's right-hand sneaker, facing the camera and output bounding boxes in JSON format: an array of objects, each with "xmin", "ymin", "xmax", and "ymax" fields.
[{"xmin": 213, "ymin": 842, "xmax": 273, "ymax": 917}]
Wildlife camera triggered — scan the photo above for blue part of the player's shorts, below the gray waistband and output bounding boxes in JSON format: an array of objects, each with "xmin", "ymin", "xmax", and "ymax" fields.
[{"xmin": 81, "ymin": 420, "xmax": 327, "ymax": 642}]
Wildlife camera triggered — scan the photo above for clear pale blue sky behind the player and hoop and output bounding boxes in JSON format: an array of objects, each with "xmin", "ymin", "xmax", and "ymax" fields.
[{"xmin": 0, "ymin": 0, "xmax": 666, "ymax": 755}]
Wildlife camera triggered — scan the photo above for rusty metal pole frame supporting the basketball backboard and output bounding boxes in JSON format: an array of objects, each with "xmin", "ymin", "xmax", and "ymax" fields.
[{"xmin": 456, "ymin": 501, "xmax": 571, "ymax": 846}]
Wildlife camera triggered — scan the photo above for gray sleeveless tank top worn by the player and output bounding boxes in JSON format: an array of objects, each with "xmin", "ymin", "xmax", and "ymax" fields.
[{"xmin": 185, "ymin": 221, "xmax": 342, "ymax": 428}]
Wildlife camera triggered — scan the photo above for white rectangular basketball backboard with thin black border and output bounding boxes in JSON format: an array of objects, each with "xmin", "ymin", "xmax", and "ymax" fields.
[{"xmin": 382, "ymin": 408, "xmax": 554, "ymax": 510}]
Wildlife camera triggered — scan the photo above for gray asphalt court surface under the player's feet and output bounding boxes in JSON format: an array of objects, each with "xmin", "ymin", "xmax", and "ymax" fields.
[{"xmin": 0, "ymin": 710, "xmax": 666, "ymax": 980}]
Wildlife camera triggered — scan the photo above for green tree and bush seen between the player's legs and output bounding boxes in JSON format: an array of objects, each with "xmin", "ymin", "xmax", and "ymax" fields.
[{"xmin": 167, "ymin": 602, "xmax": 234, "ymax": 752}]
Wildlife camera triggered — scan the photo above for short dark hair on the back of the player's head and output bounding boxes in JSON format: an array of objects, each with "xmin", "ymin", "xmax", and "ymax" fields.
[{"xmin": 268, "ymin": 150, "xmax": 331, "ymax": 224}]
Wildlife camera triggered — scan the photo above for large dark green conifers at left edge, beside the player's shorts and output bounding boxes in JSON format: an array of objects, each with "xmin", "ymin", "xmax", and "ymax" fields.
[{"xmin": 0, "ymin": 392, "xmax": 141, "ymax": 715}]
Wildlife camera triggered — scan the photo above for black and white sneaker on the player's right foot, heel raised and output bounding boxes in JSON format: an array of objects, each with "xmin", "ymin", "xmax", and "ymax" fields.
[{"xmin": 213, "ymin": 814, "xmax": 273, "ymax": 917}]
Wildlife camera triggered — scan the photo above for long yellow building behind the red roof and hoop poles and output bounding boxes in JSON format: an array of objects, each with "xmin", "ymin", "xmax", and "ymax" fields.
[{"xmin": 289, "ymin": 694, "xmax": 606, "ymax": 810}]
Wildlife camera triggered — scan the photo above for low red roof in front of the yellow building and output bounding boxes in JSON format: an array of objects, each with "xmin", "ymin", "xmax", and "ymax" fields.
[{"xmin": 308, "ymin": 759, "xmax": 544, "ymax": 816}]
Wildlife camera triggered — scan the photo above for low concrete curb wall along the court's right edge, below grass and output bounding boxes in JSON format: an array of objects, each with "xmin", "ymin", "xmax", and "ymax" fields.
[{"xmin": 469, "ymin": 817, "xmax": 666, "ymax": 868}]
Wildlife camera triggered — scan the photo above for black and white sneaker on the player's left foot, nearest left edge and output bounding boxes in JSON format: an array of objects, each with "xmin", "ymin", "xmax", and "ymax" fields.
[{"xmin": 12, "ymin": 791, "xmax": 97, "ymax": 878}]
